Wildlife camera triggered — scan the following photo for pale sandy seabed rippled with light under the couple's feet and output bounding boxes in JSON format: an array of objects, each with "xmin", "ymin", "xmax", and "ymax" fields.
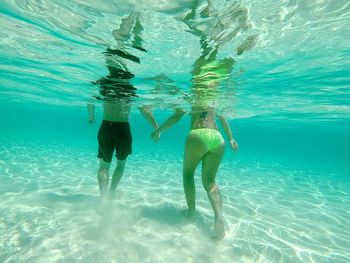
[{"xmin": 0, "ymin": 146, "xmax": 350, "ymax": 262}]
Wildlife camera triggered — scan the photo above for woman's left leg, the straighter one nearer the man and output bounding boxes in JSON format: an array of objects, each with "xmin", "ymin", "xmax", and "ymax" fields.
[{"xmin": 183, "ymin": 134, "xmax": 207, "ymax": 211}]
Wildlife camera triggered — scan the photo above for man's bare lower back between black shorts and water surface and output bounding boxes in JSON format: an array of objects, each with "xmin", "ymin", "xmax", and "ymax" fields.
[{"xmin": 103, "ymin": 101, "xmax": 131, "ymax": 122}]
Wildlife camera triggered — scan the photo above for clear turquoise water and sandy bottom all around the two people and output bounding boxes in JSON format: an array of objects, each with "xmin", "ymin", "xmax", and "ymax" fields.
[{"xmin": 0, "ymin": 0, "xmax": 350, "ymax": 262}]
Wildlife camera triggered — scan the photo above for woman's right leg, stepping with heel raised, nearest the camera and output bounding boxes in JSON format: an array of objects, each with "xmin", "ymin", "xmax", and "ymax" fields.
[{"xmin": 202, "ymin": 145, "xmax": 225, "ymax": 239}]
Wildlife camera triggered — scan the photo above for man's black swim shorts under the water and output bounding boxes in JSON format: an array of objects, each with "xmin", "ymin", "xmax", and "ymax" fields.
[{"xmin": 97, "ymin": 121, "xmax": 132, "ymax": 163}]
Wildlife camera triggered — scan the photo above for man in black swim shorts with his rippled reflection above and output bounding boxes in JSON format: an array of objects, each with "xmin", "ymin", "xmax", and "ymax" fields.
[{"xmin": 88, "ymin": 12, "xmax": 158, "ymax": 200}]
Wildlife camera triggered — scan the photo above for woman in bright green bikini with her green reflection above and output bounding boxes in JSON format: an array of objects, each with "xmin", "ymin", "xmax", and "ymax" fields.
[{"xmin": 152, "ymin": 57, "xmax": 238, "ymax": 239}]
